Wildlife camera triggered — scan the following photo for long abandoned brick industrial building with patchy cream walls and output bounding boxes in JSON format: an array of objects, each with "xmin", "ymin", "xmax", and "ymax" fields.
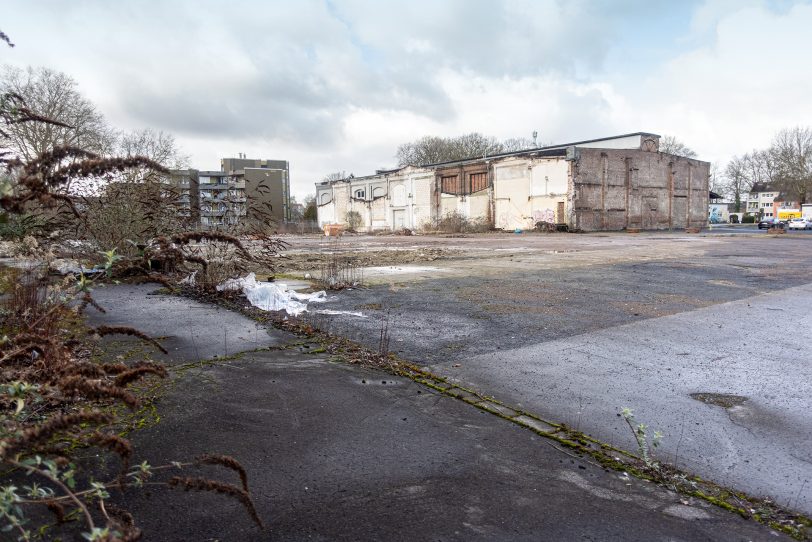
[{"xmin": 316, "ymin": 132, "xmax": 710, "ymax": 231}]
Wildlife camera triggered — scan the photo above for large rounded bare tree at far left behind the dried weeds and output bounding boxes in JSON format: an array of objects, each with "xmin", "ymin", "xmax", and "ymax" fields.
[{"xmin": 0, "ymin": 66, "xmax": 115, "ymax": 160}]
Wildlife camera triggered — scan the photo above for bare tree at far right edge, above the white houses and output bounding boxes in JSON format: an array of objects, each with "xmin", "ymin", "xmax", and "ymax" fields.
[{"xmin": 771, "ymin": 126, "xmax": 812, "ymax": 204}]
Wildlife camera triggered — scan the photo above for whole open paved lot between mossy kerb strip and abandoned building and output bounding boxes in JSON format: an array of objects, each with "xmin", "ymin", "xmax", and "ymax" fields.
[{"xmin": 290, "ymin": 230, "xmax": 812, "ymax": 514}]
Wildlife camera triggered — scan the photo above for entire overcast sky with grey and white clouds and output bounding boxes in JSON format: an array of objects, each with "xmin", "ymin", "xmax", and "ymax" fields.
[{"xmin": 0, "ymin": 0, "xmax": 812, "ymax": 201}]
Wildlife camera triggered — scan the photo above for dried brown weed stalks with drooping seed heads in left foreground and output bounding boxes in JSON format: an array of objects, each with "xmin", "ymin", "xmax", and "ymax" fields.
[{"xmin": 0, "ymin": 92, "xmax": 262, "ymax": 541}]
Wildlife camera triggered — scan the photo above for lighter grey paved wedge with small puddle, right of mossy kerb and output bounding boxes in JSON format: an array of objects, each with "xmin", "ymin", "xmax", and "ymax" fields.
[{"xmin": 444, "ymin": 285, "xmax": 812, "ymax": 514}]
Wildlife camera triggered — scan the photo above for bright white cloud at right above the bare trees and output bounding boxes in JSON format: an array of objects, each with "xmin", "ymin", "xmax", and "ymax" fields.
[{"xmin": 629, "ymin": 4, "xmax": 812, "ymax": 161}]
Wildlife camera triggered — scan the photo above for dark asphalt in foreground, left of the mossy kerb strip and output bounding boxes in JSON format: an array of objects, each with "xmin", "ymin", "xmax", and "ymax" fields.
[{"xmin": 84, "ymin": 285, "xmax": 787, "ymax": 541}]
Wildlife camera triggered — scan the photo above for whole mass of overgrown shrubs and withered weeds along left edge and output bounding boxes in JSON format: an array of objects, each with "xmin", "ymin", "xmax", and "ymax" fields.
[{"xmin": 0, "ymin": 45, "xmax": 284, "ymax": 541}]
